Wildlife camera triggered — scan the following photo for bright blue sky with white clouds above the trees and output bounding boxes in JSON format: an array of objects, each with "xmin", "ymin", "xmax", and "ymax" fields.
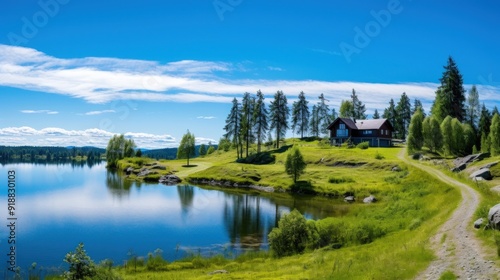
[{"xmin": 0, "ymin": 0, "xmax": 500, "ymax": 148}]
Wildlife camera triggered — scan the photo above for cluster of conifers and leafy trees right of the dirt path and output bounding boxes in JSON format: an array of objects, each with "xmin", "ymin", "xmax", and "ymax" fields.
[{"xmin": 407, "ymin": 57, "xmax": 500, "ymax": 156}]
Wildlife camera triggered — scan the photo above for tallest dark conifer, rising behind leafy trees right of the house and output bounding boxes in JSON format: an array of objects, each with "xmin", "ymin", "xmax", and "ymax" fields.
[{"xmin": 431, "ymin": 56, "xmax": 465, "ymax": 122}]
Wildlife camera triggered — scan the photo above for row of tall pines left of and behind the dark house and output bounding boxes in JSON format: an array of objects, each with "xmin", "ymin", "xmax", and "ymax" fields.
[{"xmin": 223, "ymin": 89, "xmax": 423, "ymax": 158}]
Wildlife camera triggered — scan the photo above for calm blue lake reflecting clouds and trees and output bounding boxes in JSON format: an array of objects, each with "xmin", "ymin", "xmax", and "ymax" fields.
[{"xmin": 0, "ymin": 163, "xmax": 347, "ymax": 270}]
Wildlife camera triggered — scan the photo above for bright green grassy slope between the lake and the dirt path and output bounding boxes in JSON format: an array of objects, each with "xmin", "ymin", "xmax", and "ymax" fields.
[{"xmin": 104, "ymin": 139, "xmax": 460, "ymax": 279}]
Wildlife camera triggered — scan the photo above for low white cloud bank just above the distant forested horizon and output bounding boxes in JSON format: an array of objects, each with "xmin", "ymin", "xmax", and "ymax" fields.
[{"xmin": 0, "ymin": 126, "xmax": 182, "ymax": 149}]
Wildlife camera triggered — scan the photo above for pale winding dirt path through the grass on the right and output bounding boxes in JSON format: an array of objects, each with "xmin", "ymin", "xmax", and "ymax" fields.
[{"xmin": 399, "ymin": 150, "xmax": 500, "ymax": 279}]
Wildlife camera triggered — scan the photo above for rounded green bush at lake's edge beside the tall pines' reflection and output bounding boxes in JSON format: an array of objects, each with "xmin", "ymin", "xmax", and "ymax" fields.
[{"xmin": 268, "ymin": 209, "xmax": 310, "ymax": 257}]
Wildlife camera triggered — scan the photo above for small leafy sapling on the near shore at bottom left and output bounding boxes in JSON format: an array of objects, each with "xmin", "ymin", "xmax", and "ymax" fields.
[{"xmin": 64, "ymin": 243, "xmax": 97, "ymax": 280}]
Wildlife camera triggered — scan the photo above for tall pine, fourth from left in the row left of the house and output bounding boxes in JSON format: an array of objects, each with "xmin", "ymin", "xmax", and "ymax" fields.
[{"xmin": 270, "ymin": 90, "xmax": 290, "ymax": 148}]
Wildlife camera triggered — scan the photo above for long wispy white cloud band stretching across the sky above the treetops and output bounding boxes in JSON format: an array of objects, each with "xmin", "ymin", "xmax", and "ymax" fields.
[{"xmin": 0, "ymin": 45, "xmax": 500, "ymax": 112}]
